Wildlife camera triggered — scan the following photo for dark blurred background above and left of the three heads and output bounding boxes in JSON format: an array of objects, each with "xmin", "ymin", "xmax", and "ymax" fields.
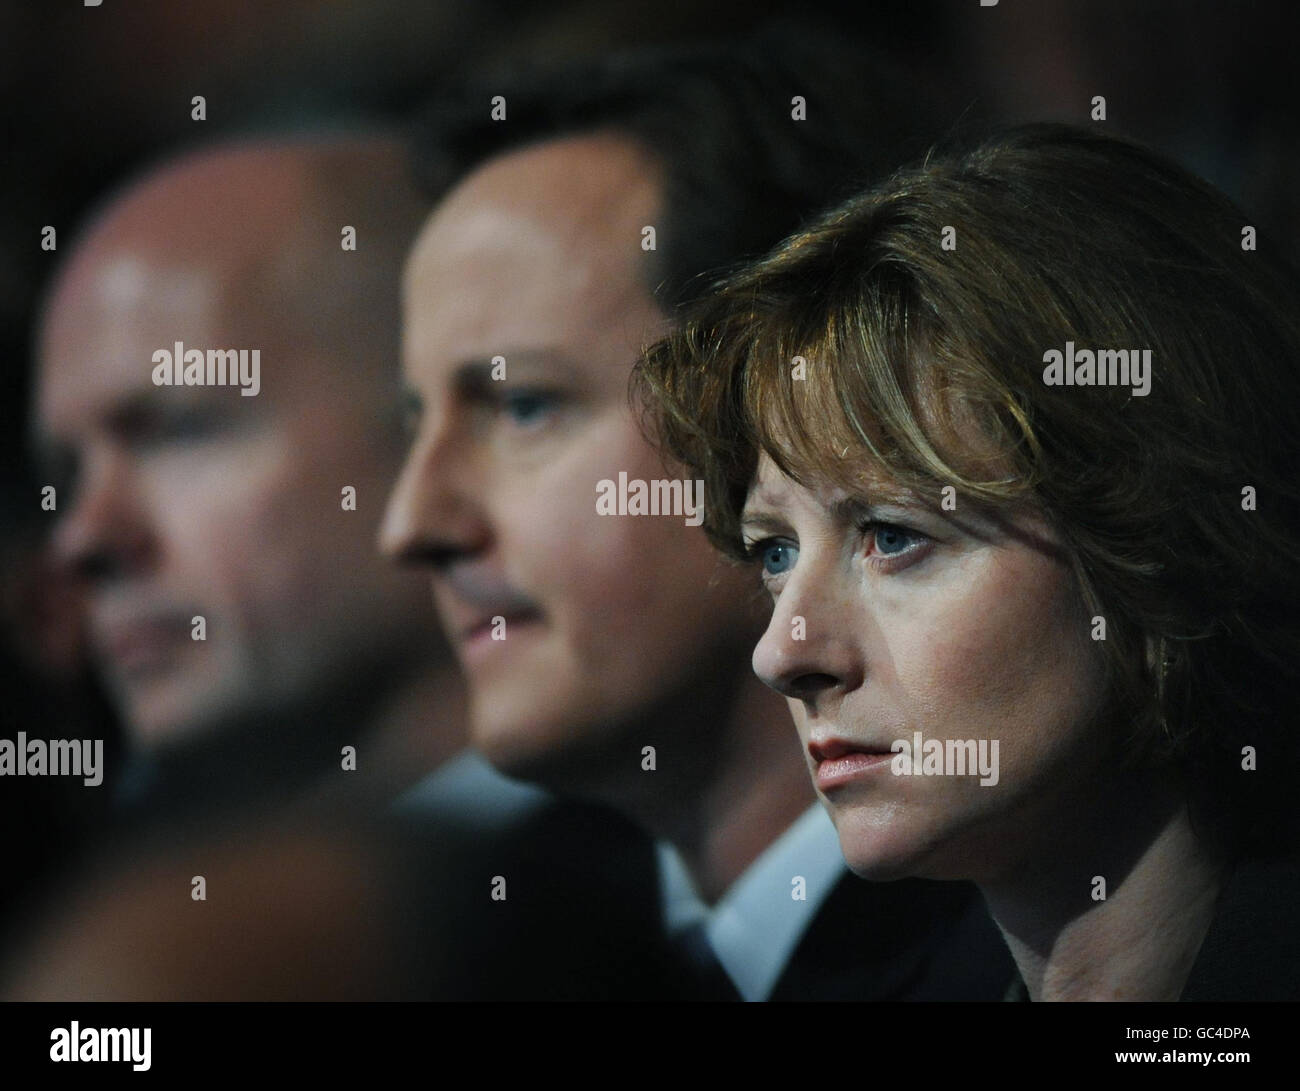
[{"xmin": 0, "ymin": 0, "xmax": 1300, "ymax": 946}]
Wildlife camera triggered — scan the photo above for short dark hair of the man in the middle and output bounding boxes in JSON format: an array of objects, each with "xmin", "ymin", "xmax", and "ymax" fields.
[{"xmin": 416, "ymin": 25, "xmax": 956, "ymax": 309}]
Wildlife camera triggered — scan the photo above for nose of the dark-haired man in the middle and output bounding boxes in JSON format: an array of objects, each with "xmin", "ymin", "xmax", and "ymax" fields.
[{"xmin": 380, "ymin": 434, "xmax": 488, "ymax": 564}]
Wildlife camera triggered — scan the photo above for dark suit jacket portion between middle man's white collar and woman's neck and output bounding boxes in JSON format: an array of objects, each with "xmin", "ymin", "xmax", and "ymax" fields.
[{"xmin": 771, "ymin": 874, "xmax": 1015, "ymax": 1000}]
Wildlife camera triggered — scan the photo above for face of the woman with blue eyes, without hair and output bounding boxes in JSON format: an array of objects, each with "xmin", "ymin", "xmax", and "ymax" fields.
[{"xmin": 742, "ymin": 456, "xmax": 1117, "ymax": 882}]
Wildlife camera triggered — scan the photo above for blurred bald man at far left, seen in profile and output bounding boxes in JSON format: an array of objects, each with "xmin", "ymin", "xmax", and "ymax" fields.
[{"xmin": 35, "ymin": 137, "xmax": 463, "ymax": 816}]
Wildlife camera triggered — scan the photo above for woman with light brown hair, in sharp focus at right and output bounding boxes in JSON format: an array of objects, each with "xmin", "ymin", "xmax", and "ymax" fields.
[{"xmin": 638, "ymin": 126, "xmax": 1300, "ymax": 1000}]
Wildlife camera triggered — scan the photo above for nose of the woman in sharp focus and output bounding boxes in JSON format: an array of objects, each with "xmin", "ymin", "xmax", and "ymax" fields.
[{"xmin": 753, "ymin": 557, "xmax": 866, "ymax": 705}]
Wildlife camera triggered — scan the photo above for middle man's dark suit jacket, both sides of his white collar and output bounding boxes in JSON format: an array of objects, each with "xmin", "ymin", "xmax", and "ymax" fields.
[{"xmin": 397, "ymin": 802, "xmax": 1014, "ymax": 1001}]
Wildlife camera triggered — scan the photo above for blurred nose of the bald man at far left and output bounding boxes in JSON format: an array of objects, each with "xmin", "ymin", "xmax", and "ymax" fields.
[{"xmin": 51, "ymin": 453, "xmax": 152, "ymax": 577}]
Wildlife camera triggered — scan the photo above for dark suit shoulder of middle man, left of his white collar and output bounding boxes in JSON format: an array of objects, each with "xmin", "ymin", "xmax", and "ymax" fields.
[{"xmin": 393, "ymin": 801, "xmax": 714, "ymax": 1001}]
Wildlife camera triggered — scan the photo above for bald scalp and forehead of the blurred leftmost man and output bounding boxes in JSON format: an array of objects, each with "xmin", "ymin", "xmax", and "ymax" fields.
[{"xmin": 43, "ymin": 137, "xmax": 426, "ymax": 410}]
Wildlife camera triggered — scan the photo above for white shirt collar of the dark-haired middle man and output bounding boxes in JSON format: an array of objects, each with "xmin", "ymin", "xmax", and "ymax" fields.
[{"xmin": 655, "ymin": 804, "xmax": 846, "ymax": 1000}]
